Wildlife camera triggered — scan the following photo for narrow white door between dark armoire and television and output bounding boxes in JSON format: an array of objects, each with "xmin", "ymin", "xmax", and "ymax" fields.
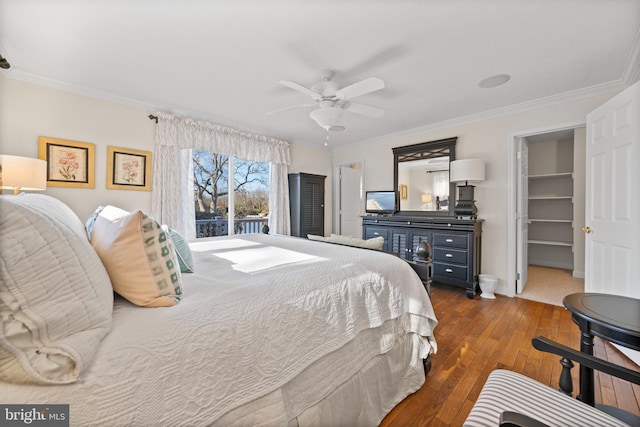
[{"xmin": 340, "ymin": 166, "xmax": 362, "ymax": 237}]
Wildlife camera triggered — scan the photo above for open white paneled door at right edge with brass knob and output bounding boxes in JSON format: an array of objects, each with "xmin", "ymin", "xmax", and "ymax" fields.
[{"xmin": 583, "ymin": 83, "xmax": 640, "ymax": 298}]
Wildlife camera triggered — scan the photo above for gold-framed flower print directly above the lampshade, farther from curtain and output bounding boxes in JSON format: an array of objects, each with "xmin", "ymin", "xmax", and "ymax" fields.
[{"xmin": 38, "ymin": 136, "xmax": 95, "ymax": 188}]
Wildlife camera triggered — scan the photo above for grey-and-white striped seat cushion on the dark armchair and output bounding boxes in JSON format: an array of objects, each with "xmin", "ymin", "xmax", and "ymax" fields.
[{"xmin": 463, "ymin": 369, "xmax": 627, "ymax": 427}]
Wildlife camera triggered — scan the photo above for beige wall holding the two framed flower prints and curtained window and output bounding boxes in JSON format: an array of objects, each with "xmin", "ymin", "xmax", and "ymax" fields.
[{"xmin": 0, "ymin": 76, "xmax": 331, "ymax": 231}]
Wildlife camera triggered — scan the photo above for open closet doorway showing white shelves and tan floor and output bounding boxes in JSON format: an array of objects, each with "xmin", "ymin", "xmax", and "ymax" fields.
[{"xmin": 516, "ymin": 127, "xmax": 586, "ymax": 305}]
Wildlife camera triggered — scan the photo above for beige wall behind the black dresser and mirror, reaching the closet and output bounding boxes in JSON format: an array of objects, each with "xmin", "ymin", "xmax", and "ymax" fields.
[{"xmin": 333, "ymin": 94, "xmax": 613, "ymax": 295}]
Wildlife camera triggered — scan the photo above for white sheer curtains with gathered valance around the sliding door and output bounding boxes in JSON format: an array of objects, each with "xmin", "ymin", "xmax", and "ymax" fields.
[{"xmin": 151, "ymin": 113, "xmax": 291, "ymax": 239}]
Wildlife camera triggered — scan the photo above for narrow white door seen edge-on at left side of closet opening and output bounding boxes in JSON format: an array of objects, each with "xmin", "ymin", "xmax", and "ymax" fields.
[{"xmin": 516, "ymin": 138, "xmax": 529, "ymax": 294}]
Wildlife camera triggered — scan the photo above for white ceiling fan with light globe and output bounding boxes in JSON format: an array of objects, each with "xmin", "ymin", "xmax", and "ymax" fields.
[{"xmin": 267, "ymin": 70, "xmax": 384, "ymax": 132}]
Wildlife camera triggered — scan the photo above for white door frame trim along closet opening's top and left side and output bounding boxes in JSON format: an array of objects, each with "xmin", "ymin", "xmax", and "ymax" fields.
[{"xmin": 506, "ymin": 116, "xmax": 587, "ymax": 297}]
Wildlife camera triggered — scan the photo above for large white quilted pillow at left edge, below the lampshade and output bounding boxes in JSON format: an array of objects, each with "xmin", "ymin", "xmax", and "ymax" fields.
[{"xmin": 0, "ymin": 194, "xmax": 113, "ymax": 384}]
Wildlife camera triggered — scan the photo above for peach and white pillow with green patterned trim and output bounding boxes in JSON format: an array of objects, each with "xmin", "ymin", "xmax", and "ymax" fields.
[{"xmin": 91, "ymin": 206, "xmax": 182, "ymax": 307}]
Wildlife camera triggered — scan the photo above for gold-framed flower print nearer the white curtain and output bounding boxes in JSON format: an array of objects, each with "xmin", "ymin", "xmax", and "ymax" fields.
[{"xmin": 107, "ymin": 145, "xmax": 151, "ymax": 191}]
